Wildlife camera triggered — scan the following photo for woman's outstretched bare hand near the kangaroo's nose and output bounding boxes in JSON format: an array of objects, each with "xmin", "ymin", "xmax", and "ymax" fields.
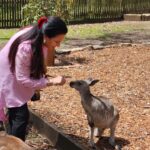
[{"xmin": 47, "ymin": 76, "xmax": 66, "ymax": 86}]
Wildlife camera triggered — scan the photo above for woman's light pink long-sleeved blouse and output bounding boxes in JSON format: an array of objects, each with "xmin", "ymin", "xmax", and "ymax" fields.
[{"xmin": 0, "ymin": 28, "xmax": 48, "ymax": 121}]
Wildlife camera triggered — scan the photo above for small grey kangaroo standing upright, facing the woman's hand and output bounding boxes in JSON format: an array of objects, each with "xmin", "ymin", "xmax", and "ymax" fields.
[{"xmin": 70, "ymin": 78, "xmax": 119, "ymax": 148}]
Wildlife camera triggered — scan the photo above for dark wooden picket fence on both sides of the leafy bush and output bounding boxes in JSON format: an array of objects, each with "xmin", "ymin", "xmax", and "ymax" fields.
[{"xmin": 0, "ymin": 0, "xmax": 150, "ymax": 28}]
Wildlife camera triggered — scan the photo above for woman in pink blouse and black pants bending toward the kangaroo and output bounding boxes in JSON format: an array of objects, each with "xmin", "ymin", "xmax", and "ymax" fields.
[{"xmin": 0, "ymin": 17, "xmax": 67, "ymax": 141}]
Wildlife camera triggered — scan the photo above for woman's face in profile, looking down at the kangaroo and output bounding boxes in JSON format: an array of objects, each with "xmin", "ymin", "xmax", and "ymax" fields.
[{"xmin": 44, "ymin": 34, "xmax": 65, "ymax": 49}]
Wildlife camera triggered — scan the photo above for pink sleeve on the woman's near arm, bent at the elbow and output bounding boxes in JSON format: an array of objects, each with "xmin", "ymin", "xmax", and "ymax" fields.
[{"xmin": 15, "ymin": 42, "xmax": 48, "ymax": 89}]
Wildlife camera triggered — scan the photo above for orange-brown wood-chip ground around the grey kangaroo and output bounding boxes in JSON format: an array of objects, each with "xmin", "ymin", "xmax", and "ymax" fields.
[{"xmin": 29, "ymin": 45, "xmax": 150, "ymax": 150}]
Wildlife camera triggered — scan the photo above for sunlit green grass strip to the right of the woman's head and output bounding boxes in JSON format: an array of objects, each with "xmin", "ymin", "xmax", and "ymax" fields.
[{"xmin": 66, "ymin": 22, "xmax": 150, "ymax": 39}]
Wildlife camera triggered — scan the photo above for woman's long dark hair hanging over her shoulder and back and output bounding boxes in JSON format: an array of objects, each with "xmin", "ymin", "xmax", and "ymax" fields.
[{"xmin": 8, "ymin": 16, "xmax": 68, "ymax": 79}]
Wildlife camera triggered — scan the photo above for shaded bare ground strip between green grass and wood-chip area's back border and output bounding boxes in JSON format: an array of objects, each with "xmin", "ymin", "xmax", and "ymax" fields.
[{"xmin": 61, "ymin": 30, "xmax": 150, "ymax": 49}]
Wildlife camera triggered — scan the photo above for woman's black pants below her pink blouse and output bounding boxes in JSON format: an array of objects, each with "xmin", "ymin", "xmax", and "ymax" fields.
[{"xmin": 8, "ymin": 104, "xmax": 29, "ymax": 141}]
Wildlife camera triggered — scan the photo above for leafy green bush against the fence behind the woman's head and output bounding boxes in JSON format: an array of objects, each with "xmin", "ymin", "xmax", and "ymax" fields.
[{"xmin": 22, "ymin": 0, "xmax": 73, "ymax": 25}]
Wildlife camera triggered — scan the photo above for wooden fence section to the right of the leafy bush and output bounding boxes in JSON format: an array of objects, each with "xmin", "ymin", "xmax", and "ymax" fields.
[{"xmin": 71, "ymin": 0, "xmax": 150, "ymax": 22}]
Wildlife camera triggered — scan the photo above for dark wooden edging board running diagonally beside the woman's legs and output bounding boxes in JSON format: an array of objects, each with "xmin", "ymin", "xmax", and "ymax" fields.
[{"xmin": 29, "ymin": 109, "xmax": 84, "ymax": 150}]
